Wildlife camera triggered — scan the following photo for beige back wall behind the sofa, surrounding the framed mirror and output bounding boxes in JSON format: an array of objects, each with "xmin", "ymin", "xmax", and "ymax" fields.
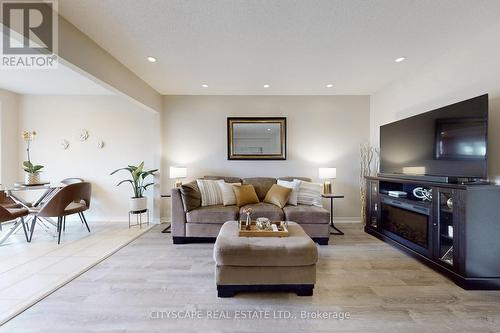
[{"xmin": 161, "ymin": 96, "xmax": 369, "ymax": 220}]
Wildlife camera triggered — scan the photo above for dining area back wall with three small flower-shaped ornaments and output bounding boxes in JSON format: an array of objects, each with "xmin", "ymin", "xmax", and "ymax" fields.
[{"xmin": 17, "ymin": 95, "xmax": 160, "ymax": 221}]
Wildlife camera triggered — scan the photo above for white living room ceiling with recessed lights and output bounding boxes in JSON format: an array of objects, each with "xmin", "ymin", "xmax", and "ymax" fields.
[{"xmin": 59, "ymin": 0, "xmax": 500, "ymax": 95}]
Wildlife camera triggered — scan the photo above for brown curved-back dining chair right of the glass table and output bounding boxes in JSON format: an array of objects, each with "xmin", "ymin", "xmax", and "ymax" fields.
[{"xmin": 29, "ymin": 182, "xmax": 92, "ymax": 244}]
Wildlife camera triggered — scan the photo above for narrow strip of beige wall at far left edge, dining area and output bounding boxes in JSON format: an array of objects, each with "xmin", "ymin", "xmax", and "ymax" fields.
[{"xmin": 0, "ymin": 89, "xmax": 21, "ymax": 184}]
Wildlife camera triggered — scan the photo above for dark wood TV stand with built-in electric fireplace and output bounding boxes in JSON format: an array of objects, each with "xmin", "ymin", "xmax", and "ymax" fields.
[{"xmin": 365, "ymin": 177, "xmax": 500, "ymax": 290}]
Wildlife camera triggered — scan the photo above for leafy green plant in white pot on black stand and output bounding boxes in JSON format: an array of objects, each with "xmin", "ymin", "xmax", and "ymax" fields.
[{"xmin": 111, "ymin": 162, "xmax": 158, "ymax": 212}]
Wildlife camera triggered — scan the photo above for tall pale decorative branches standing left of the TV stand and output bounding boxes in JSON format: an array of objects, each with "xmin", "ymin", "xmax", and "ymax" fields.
[{"xmin": 359, "ymin": 144, "xmax": 380, "ymax": 223}]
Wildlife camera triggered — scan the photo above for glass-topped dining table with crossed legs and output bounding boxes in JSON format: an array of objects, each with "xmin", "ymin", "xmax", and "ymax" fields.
[{"xmin": 0, "ymin": 182, "xmax": 65, "ymax": 236}]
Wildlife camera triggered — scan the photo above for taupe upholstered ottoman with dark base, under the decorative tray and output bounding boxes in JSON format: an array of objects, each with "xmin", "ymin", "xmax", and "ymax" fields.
[{"xmin": 214, "ymin": 221, "xmax": 318, "ymax": 297}]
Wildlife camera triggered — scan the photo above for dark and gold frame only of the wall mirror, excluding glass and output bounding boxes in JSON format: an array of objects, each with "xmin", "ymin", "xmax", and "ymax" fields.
[{"xmin": 227, "ymin": 117, "xmax": 286, "ymax": 160}]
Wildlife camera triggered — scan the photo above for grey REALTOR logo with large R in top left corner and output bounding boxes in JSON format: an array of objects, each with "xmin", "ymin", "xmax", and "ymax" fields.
[{"xmin": 1, "ymin": 0, "xmax": 58, "ymax": 69}]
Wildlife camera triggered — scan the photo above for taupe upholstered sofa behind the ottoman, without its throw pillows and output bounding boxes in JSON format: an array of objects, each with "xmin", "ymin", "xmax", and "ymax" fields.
[{"xmin": 172, "ymin": 176, "xmax": 330, "ymax": 245}]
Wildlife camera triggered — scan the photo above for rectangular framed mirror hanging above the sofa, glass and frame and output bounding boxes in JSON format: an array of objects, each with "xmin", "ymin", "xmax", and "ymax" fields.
[{"xmin": 227, "ymin": 117, "xmax": 286, "ymax": 160}]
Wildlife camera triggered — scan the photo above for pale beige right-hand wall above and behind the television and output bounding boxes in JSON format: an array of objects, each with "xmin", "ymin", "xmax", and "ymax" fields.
[{"xmin": 370, "ymin": 24, "xmax": 500, "ymax": 182}]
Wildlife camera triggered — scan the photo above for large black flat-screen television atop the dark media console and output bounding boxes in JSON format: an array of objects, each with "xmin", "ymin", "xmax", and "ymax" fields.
[{"xmin": 380, "ymin": 94, "xmax": 488, "ymax": 180}]
